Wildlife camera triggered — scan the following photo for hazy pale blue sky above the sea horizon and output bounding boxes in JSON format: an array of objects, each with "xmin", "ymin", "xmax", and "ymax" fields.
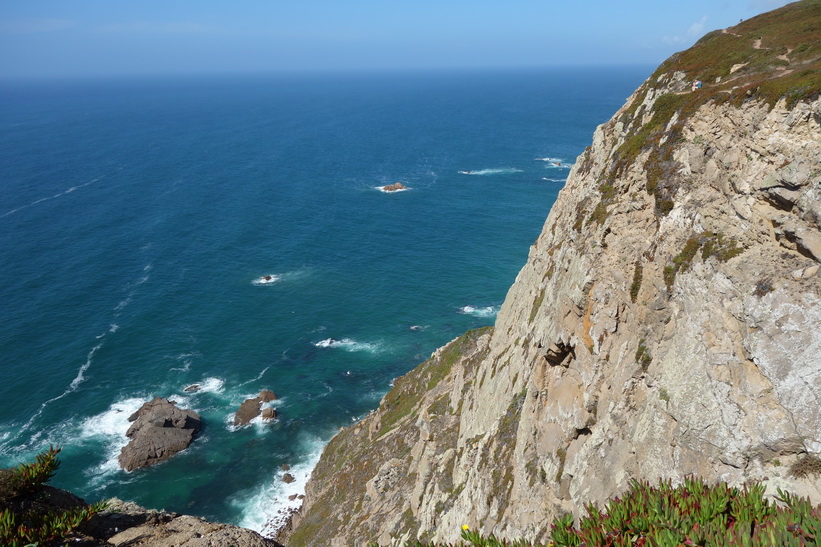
[{"xmin": 0, "ymin": 0, "xmax": 788, "ymax": 79}]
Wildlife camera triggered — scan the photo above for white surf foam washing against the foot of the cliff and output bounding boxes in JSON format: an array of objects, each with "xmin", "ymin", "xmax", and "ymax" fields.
[{"xmin": 230, "ymin": 438, "xmax": 325, "ymax": 537}]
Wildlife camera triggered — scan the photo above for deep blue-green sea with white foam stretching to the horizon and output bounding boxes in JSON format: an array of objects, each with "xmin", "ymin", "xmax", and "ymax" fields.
[{"xmin": 0, "ymin": 67, "xmax": 650, "ymax": 531}]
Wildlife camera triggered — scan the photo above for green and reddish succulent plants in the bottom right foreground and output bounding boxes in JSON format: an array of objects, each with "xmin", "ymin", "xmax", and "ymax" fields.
[{"xmin": 552, "ymin": 478, "xmax": 821, "ymax": 547}]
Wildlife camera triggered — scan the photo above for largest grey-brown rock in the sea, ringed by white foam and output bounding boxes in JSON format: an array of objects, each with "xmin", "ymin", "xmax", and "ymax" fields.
[{"xmin": 118, "ymin": 397, "xmax": 202, "ymax": 471}]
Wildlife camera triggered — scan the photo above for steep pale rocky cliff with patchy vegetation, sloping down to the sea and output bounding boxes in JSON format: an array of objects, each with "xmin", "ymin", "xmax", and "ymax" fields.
[{"xmin": 288, "ymin": 0, "xmax": 821, "ymax": 546}]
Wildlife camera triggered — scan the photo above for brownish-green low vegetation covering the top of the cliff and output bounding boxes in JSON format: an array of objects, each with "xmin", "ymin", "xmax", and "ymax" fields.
[{"xmin": 594, "ymin": 0, "xmax": 821, "ymax": 216}]
